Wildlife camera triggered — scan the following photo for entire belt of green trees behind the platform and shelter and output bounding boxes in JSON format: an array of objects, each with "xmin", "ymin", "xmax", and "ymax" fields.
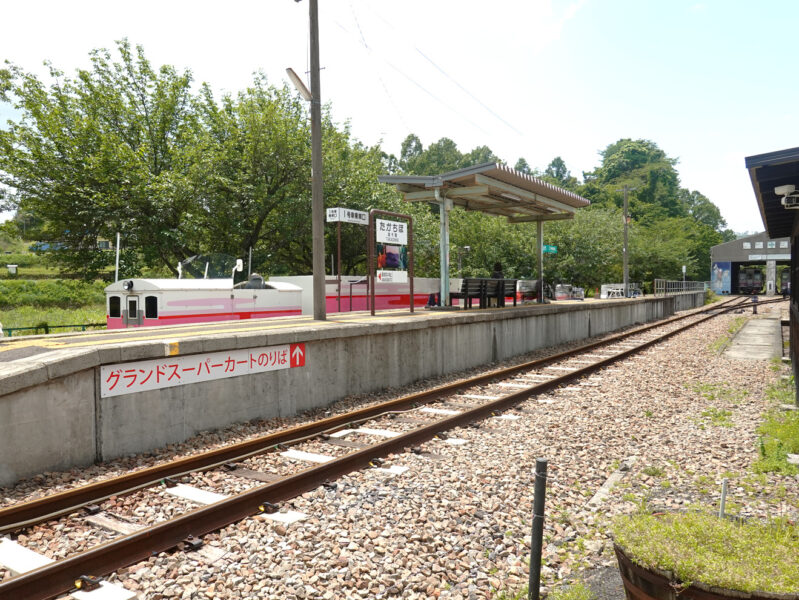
[{"xmin": 0, "ymin": 40, "xmax": 734, "ymax": 288}]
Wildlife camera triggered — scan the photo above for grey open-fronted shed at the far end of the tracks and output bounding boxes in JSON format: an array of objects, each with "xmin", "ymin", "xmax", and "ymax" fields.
[{"xmin": 710, "ymin": 232, "xmax": 791, "ymax": 296}]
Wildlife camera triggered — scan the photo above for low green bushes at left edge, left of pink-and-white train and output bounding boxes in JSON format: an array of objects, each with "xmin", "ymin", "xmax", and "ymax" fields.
[{"xmin": 0, "ymin": 279, "xmax": 106, "ymax": 309}]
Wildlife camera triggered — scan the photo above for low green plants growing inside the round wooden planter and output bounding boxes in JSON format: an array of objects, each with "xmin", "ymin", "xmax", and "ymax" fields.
[{"xmin": 613, "ymin": 512, "xmax": 799, "ymax": 593}]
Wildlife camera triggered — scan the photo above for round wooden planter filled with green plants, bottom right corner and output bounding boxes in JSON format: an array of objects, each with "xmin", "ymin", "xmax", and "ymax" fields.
[{"xmin": 613, "ymin": 512, "xmax": 799, "ymax": 600}]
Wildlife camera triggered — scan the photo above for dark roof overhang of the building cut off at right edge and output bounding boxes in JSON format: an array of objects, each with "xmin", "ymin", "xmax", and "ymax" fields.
[{"xmin": 746, "ymin": 148, "xmax": 799, "ymax": 239}]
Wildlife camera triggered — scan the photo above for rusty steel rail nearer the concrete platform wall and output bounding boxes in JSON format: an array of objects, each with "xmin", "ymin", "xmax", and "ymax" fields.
[{"xmin": 0, "ymin": 298, "xmax": 748, "ymax": 533}]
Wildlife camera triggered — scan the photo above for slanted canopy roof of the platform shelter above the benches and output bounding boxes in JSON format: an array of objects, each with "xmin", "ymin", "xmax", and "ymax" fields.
[{"xmin": 378, "ymin": 162, "xmax": 590, "ymax": 223}]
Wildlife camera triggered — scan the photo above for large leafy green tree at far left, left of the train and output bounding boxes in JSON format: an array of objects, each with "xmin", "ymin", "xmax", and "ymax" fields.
[{"xmin": 0, "ymin": 40, "xmax": 194, "ymax": 278}]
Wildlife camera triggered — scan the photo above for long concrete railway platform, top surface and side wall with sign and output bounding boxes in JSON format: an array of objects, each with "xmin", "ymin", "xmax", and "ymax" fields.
[{"xmin": 0, "ymin": 293, "xmax": 703, "ymax": 485}]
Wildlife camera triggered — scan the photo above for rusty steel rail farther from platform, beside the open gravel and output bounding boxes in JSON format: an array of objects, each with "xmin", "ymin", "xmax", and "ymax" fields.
[{"xmin": 0, "ymin": 296, "xmax": 768, "ymax": 600}]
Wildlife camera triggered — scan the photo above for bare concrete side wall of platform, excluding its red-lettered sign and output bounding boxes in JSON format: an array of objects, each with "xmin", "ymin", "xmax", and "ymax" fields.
[{"xmin": 0, "ymin": 294, "xmax": 702, "ymax": 485}]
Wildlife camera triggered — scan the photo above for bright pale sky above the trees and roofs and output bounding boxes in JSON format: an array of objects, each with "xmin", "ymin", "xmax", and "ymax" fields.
[{"xmin": 0, "ymin": 0, "xmax": 799, "ymax": 232}]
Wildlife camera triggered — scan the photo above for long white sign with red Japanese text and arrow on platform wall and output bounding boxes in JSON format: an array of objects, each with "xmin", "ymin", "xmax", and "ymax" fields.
[{"xmin": 100, "ymin": 344, "xmax": 305, "ymax": 398}]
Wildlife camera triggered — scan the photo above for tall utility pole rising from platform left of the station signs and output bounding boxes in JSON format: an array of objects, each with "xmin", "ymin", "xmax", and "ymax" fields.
[{"xmin": 308, "ymin": 0, "xmax": 327, "ymax": 321}]
